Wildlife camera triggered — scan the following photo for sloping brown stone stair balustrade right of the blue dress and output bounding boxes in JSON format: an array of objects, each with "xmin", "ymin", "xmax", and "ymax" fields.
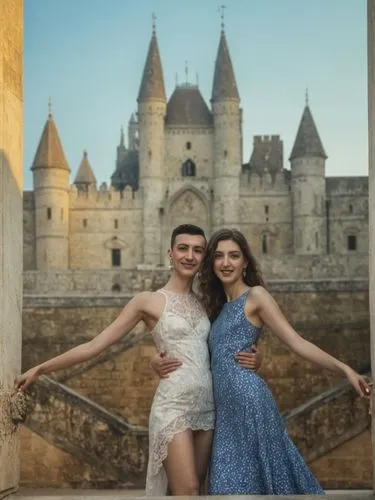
[{"xmin": 283, "ymin": 370, "xmax": 370, "ymax": 462}]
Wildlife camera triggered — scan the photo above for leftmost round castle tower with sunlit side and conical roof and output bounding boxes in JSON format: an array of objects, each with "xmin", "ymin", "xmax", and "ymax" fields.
[{"xmin": 31, "ymin": 102, "xmax": 70, "ymax": 270}]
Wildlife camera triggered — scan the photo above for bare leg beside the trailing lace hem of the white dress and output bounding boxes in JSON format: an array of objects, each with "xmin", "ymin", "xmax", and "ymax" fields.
[{"xmin": 163, "ymin": 429, "xmax": 199, "ymax": 496}]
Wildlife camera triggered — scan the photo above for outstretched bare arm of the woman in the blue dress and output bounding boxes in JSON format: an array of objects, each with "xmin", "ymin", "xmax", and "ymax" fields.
[{"xmin": 252, "ymin": 286, "xmax": 370, "ymax": 396}]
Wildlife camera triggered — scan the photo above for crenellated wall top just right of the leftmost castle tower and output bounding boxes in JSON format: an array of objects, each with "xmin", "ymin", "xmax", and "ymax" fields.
[{"xmin": 69, "ymin": 183, "xmax": 143, "ymax": 210}]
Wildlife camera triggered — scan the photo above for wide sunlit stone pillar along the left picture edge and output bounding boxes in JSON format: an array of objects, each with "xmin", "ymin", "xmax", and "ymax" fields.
[{"xmin": 0, "ymin": 0, "xmax": 23, "ymax": 497}]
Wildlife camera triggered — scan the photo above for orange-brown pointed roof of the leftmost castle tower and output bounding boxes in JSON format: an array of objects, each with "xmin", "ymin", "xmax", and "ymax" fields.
[{"xmin": 31, "ymin": 102, "xmax": 70, "ymax": 171}]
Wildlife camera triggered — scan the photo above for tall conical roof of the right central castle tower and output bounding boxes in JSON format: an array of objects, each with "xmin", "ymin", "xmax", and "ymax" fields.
[{"xmin": 211, "ymin": 29, "xmax": 240, "ymax": 101}]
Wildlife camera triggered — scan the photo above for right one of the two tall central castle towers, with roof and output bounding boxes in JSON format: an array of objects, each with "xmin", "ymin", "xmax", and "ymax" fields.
[{"xmin": 211, "ymin": 24, "xmax": 242, "ymax": 231}]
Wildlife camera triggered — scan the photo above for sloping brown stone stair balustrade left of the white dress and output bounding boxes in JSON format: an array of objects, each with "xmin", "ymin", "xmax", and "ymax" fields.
[{"xmin": 24, "ymin": 376, "xmax": 148, "ymax": 488}]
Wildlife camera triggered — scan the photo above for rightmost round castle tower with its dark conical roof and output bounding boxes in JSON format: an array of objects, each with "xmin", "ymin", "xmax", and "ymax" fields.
[{"xmin": 289, "ymin": 98, "xmax": 327, "ymax": 255}]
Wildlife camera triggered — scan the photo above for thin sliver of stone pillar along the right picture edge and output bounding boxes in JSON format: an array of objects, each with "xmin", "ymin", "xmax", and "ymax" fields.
[{"xmin": 367, "ymin": 0, "xmax": 375, "ymax": 490}]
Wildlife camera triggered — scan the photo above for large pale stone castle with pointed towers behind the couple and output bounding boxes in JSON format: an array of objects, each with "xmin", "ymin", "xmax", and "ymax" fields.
[{"xmin": 24, "ymin": 22, "xmax": 368, "ymax": 271}]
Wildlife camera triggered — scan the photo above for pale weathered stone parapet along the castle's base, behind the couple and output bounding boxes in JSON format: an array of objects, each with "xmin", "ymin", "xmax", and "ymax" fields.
[{"xmin": 23, "ymin": 254, "xmax": 368, "ymax": 297}]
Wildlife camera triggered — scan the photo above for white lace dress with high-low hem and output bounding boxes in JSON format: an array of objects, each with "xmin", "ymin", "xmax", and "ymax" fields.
[{"xmin": 146, "ymin": 289, "xmax": 214, "ymax": 496}]
